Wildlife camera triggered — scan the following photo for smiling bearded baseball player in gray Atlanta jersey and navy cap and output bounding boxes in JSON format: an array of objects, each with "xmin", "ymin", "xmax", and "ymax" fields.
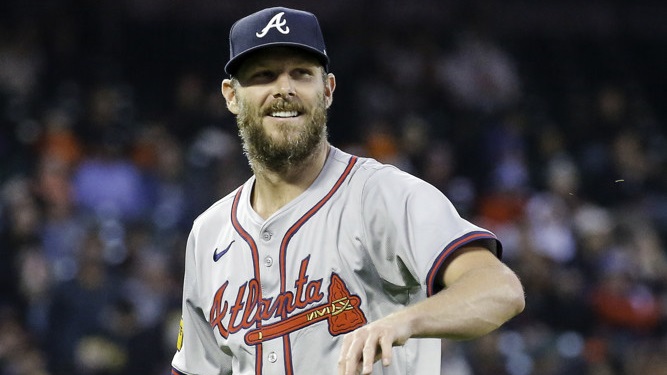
[{"xmin": 172, "ymin": 8, "xmax": 524, "ymax": 375}]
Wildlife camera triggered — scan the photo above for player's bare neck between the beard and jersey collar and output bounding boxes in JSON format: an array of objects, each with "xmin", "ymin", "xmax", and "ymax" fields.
[{"xmin": 250, "ymin": 141, "xmax": 330, "ymax": 219}]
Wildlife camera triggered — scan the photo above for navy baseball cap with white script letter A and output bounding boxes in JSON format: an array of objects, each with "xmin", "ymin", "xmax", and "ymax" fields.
[{"xmin": 225, "ymin": 7, "xmax": 329, "ymax": 75}]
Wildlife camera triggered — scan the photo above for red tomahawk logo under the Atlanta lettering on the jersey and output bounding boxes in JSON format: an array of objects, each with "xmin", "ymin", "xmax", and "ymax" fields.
[{"xmin": 245, "ymin": 274, "xmax": 366, "ymax": 345}]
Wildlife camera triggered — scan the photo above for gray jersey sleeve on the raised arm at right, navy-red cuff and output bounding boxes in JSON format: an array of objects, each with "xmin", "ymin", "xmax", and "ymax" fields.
[{"xmin": 361, "ymin": 166, "xmax": 501, "ymax": 295}]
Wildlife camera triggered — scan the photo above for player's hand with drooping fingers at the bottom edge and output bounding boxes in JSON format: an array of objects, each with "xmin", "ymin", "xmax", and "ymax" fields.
[{"xmin": 338, "ymin": 314, "xmax": 411, "ymax": 375}]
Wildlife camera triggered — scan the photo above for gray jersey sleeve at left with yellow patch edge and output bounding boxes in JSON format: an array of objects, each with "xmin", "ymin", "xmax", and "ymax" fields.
[{"xmin": 171, "ymin": 231, "xmax": 232, "ymax": 375}]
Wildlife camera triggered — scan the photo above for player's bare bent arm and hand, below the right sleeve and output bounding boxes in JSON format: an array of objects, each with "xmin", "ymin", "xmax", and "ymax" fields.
[{"xmin": 338, "ymin": 246, "xmax": 525, "ymax": 375}]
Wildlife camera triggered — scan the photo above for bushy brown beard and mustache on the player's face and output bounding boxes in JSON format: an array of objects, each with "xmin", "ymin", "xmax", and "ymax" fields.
[{"xmin": 236, "ymin": 95, "xmax": 327, "ymax": 172}]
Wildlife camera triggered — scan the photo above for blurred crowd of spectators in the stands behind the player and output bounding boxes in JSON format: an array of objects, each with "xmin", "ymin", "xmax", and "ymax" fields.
[{"xmin": 0, "ymin": 0, "xmax": 667, "ymax": 375}]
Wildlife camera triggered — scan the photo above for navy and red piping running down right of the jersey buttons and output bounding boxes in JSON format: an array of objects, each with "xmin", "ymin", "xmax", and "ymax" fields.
[{"xmin": 280, "ymin": 156, "xmax": 358, "ymax": 375}]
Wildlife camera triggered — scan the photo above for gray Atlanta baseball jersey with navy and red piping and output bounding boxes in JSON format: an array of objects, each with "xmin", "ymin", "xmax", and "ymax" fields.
[{"xmin": 172, "ymin": 147, "xmax": 500, "ymax": 375}]
